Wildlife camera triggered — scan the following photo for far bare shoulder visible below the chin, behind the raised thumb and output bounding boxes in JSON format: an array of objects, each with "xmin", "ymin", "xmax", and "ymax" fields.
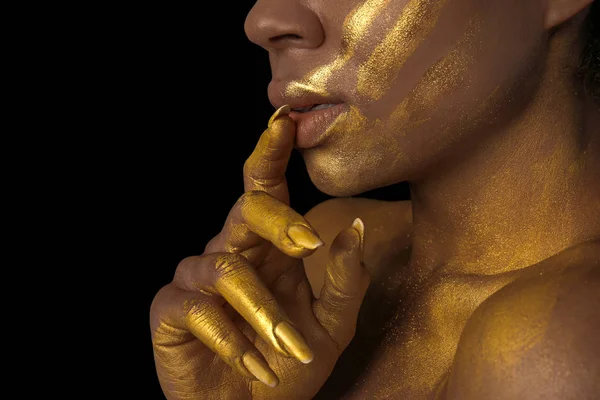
[{"xmin": 304, "ymin": 198, "xmax": 412, "ymax": 296}]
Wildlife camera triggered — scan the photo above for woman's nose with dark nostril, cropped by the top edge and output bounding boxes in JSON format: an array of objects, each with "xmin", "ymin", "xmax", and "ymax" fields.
[{"xmin": 244, "ymin": 0, "xmax": 324, "ymax": 51}]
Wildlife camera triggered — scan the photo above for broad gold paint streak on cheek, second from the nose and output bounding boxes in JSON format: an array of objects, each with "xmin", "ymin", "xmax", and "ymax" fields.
[{"xmin": 357, "ymin": 0, "xmax": 447, "ymax": 100}]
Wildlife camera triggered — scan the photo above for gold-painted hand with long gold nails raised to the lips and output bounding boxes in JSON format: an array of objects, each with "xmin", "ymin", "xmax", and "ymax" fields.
[{"xmin": 150, "ymin": 107, "xmax": 369, "ymax": 400}]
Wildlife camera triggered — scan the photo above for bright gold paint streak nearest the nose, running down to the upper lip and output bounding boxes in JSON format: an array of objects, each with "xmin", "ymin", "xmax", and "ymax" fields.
[{"xmin": 285, "ymin": 0, "xmax": 390, "ymax": 96}]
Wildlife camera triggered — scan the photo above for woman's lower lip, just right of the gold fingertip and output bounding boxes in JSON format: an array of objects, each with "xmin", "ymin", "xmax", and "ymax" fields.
[{"xmin": 290, "ymin": 103, "xmax": 347, "ymax": 149}]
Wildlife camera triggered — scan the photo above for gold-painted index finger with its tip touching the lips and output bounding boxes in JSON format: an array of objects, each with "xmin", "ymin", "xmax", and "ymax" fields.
[{"xmin": 244, "ymin": 105, "xmax": 296, "ymax": 205}]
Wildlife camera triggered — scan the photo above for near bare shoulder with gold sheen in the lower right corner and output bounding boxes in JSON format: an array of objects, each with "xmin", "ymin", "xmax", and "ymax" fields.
[{"xmin": 445, "ymin": 240, "xmax": 600, "ymax": 400}]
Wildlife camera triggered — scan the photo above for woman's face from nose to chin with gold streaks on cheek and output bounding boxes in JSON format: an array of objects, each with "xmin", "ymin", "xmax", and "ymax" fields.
[{"xmin": 245, "ymin": 0, "xmax": 545, "ymax": 196}]
